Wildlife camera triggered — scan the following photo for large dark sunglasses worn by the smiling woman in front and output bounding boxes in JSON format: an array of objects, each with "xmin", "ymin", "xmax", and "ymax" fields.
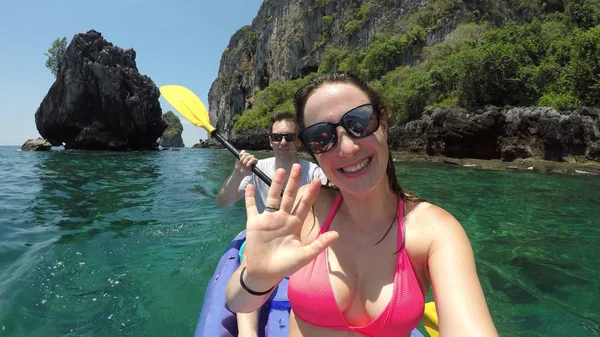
[{"xmin": 299, "ymin": 103, "xmax": 379, "ymax": 154}]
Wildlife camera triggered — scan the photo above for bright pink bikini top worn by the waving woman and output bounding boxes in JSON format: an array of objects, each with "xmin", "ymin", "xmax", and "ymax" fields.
[{"xmin": 288, "ymin": 194, "xmax": 425, "ymax": 337}]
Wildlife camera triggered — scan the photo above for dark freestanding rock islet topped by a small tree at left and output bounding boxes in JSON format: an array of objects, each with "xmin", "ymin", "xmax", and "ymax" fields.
[{"xmin": 35, "ymin": 30, "xmax": 167, "ymax": 151}]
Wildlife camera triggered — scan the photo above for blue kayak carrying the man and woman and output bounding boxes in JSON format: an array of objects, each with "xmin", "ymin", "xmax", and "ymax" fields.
[{"xmin": 194, "ymin": 230, "xmax": 437, "ymax": 337}]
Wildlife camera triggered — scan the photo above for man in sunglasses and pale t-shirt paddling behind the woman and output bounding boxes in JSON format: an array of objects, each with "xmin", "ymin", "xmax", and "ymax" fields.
[{"xmin": 217, "ymin": 112, "xmax": 327, "ymax": 337}]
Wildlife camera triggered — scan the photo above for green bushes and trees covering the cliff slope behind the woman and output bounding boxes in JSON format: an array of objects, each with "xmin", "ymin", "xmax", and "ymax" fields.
[{"xmin": 234, "ymin": 0, "xmax": 600, "ymax": 131}]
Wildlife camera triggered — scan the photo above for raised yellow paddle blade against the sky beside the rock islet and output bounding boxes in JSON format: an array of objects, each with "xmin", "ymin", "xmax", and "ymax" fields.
[{"xmin": 159, "ymin": 85, "xmax": 215, "ymax": 134}]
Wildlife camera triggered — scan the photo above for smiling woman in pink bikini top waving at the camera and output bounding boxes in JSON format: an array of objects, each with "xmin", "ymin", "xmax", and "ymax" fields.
[{"xmin": 227, "ymin": 74, "xmax": 497, "ymax": 337}]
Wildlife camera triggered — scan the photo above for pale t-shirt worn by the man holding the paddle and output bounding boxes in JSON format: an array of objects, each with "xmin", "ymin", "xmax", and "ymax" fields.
[{"xmin": 239, "ymin": 157, "xmax": 327, "ymax": 213}]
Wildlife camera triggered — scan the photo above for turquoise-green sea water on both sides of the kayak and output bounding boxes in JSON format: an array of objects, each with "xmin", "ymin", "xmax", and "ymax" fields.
[{"xmin": 0, "ymin": 147, "xmax": 600, "ymax": 337}]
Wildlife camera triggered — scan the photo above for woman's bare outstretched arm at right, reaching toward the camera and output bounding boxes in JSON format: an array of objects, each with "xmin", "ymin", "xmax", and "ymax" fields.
[{"xmin": 424, "ymin": 206, "xmax": 498, "ymax": 337}]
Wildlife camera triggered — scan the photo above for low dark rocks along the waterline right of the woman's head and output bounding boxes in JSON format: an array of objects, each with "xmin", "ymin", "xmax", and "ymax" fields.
[{"xmin": 390, "ymin": 106, "xmax": 600, "ymax": 161}]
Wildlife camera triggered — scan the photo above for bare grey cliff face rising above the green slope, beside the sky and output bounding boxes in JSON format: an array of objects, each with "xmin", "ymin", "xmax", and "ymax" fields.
[{"xmin": 208, "ymin": 0, "xmax": 428, "ymax": 137}]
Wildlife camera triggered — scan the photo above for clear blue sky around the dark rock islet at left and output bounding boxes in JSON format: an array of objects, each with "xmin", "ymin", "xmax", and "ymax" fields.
[{"xmin": 0, "ymin": 0, "xmax": 262, "ymax": 147}]
